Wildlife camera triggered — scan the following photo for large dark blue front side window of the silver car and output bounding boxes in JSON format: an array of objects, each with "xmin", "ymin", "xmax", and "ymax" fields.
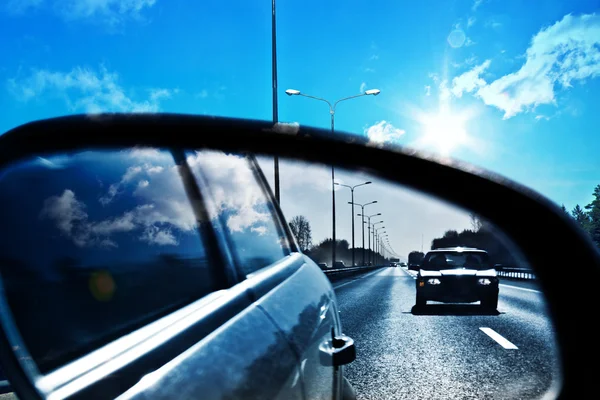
[{"xmin": 0, "ymin": 149, "xmax": 214, "ymax": 372}]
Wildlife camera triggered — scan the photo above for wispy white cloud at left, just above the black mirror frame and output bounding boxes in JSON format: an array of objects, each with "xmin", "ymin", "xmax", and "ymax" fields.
[{"xmin": 8, "ymin": 67, "xmax": 174, "ymax": 113}]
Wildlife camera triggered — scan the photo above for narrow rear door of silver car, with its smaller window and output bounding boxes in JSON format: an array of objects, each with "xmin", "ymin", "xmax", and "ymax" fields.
[{"xmin": 188, "ymin": 152, "xmax": 342, "ymax": 400}]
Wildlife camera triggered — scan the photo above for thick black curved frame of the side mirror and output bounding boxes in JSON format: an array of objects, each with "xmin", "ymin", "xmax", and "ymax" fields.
[{"xmin": 0, "ymin": 114, "xmax": 600, "ymax": 398}]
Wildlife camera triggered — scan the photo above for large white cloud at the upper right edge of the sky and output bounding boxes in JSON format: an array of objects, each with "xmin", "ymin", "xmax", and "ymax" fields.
[{"xmin": 468, "ymin": 14, "xmax": 600, "ymax": 119}]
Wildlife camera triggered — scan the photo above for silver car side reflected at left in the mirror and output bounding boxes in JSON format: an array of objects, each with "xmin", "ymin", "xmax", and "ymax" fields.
[{"xmin": 0, "ymin": 149, "xmax": 356, "ymax": 400}]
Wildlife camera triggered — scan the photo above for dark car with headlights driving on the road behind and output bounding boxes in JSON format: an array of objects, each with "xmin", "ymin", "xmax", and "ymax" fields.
[{"xmin": 416, "ymin": 247, "xmax": 498, "ymax": 310}]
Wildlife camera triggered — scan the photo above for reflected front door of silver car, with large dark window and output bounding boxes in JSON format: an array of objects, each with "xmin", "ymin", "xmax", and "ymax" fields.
[{"xmin": 0, "ymin": 149, "xmax": 302, "ymax": 399}]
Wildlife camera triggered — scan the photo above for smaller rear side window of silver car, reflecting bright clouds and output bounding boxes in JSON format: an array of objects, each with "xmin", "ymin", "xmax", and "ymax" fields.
[{"xmin": 188, "ymin": 151, "xmax": 290, "ymax": 275}]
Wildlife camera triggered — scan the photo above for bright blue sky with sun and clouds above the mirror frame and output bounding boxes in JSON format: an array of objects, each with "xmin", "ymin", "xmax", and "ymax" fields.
[{"xmin": 0, "ymin": 0, "xmax": 600, "ymax": 256}]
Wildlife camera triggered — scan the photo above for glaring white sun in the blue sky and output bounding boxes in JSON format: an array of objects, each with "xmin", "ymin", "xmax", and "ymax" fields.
[{"xmin": 415, "ymin": 107, "xmax": 473, "ymax": 156}]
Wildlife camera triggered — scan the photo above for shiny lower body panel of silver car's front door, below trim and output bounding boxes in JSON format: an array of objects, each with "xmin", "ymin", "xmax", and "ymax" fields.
[{"xmin": 119, "ymin": 305, "xmax": 303, "ymax": 400}]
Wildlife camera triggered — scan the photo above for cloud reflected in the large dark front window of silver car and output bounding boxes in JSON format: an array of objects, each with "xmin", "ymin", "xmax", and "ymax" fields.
[{"xmin": 40, "ymin": 149, "xmax": 199, "ymax": 247}]
